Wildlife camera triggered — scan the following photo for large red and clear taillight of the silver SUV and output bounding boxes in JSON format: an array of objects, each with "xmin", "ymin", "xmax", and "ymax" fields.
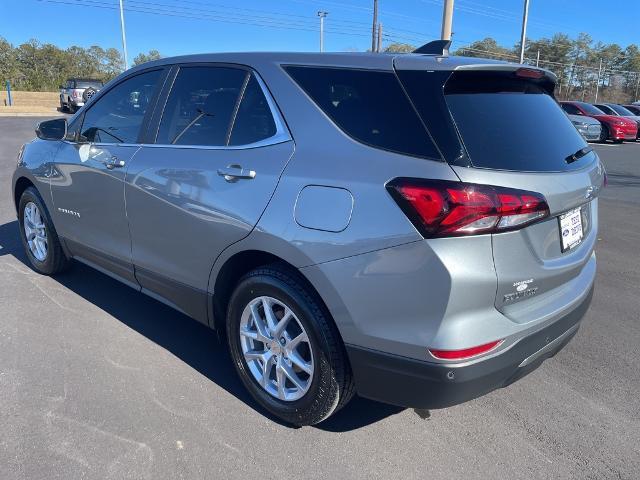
[{"xmin": 387, "ymin": 178, "xmax": 549, "ymax": 238}]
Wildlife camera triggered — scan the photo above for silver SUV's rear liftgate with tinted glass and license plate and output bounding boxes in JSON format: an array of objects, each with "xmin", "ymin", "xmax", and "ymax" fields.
[{"xmin": 399, "ymin": 66, "xmax": 604, "ymax": 323}]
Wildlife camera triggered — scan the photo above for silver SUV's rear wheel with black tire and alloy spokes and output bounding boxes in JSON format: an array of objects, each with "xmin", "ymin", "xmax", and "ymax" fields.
[{"xmin": 226, "ymin": 264, "xmax": 354, "ymax": 426}]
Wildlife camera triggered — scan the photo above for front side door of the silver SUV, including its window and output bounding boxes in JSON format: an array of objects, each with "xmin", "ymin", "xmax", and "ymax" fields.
[{"xmin": 50, "ymin": 70, "xmax": 162, "ymax": 283}]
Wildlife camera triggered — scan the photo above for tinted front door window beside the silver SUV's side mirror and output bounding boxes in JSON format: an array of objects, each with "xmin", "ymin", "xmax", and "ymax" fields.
[{"xmin": 80, "ymin": 70, "xmax": 162, "ymax": 143}]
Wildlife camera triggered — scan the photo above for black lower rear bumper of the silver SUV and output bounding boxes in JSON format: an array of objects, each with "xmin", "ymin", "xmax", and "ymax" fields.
[{"xmin": 347, "ymin": 287, "xmax": 593, "ymax": 409}]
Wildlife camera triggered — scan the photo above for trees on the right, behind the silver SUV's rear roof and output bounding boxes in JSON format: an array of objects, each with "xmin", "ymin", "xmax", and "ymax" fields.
[{"xmin": 385, "ymin": 33, "xmax": 640, "ymax": 103}]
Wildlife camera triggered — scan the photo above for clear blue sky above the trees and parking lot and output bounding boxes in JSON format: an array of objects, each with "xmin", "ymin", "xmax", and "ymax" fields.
[{"xmin": 0, "ymin": 0, "xmax": 640, "ymax": 61}]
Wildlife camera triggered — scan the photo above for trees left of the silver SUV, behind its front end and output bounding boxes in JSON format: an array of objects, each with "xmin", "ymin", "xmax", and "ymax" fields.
[{"xmin": 0, "ymin": 37, "xmax": 160, "ymax": 92}]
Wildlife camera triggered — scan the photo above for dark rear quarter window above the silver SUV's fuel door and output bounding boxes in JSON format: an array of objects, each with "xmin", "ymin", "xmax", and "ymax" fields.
[{"xmin": 286, "ymin": 67, "xmax": 440, "ymax": 158}]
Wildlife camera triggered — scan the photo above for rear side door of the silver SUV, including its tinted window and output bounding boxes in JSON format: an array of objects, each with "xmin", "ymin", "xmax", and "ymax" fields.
[{"xmin": 126, "ymin": 64, "xmax": 293, "ymax": 322}]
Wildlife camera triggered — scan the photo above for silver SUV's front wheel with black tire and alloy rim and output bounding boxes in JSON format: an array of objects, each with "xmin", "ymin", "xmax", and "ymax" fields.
[{"xmin": 18, "ymin": 187, "xmax": 70, "ymax": 275}]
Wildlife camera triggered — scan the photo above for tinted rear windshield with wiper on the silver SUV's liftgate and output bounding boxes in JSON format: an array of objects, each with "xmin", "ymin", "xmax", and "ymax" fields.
[{"xmin": 403, "ymin": 72, "xmax": 592, "ymax": 172}]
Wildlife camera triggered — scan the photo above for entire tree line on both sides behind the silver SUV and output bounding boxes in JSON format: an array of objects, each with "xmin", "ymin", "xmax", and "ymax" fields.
[{"xmin": 5, "ymin": 33, "xmax": 640, "ymax": 103}]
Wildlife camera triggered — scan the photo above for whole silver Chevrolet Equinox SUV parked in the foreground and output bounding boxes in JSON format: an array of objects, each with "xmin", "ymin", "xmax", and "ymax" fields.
[{"xmin": 13, "ymin": 45, "xmax": 605, "ymax": 425}]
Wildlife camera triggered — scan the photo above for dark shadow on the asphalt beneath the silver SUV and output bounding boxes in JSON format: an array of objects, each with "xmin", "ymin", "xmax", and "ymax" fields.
[{"xmin": 0, "ymin": 220, "xmax": 403, "ymax": 432}]
